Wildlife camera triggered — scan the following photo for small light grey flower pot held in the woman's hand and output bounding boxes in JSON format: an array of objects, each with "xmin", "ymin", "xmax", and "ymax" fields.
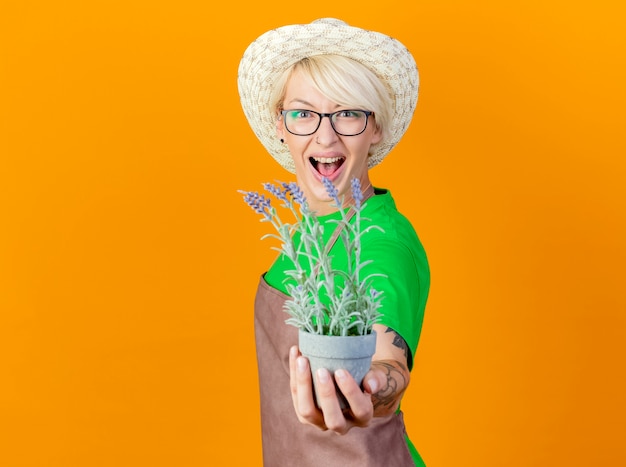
[{"xmin": 298, "ymin": 330, "xmax": 376, "ymax": 408}]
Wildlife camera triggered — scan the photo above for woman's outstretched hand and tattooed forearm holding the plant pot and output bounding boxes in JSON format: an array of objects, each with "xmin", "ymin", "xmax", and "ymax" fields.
[{"xmin": 289, "ymin": 325, "xmax": 409, "ymax": 434}]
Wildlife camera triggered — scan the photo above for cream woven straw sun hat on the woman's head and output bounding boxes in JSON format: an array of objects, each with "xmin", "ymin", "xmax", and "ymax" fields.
[{"xmin": 237, "ymin": 18, "xmax": 419, "ymax": 173}]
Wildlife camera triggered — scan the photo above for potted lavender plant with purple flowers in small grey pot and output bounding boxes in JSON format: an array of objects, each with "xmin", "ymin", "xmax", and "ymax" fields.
[{"xmin": 241, "ymin": 178, "xmax": 382, "ymax": 406}]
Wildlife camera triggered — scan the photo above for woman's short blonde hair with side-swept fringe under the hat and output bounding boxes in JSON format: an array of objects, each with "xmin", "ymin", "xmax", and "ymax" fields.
[{"xmin": 270, "ymin": 55, "xmax": 393, "ymax": 144}]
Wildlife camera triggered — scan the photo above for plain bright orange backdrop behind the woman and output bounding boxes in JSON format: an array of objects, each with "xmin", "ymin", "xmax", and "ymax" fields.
[{"xmin": 0, "ymin": 0, "xmax": 626, "ymax": 467}]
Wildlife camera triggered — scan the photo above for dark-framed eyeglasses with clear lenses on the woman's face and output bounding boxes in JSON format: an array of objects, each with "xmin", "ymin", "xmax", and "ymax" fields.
[{"xmin": 280, "ymin": 109, "xmax": 374, "ymax": 136}]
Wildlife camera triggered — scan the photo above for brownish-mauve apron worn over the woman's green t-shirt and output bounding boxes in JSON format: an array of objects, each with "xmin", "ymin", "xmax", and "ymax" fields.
[{"xmin": 254, "ymin": 188, "xmax": 414, "ymax": 467}]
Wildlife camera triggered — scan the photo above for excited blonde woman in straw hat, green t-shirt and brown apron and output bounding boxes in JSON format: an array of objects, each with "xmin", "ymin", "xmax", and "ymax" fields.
[{"xmin": 238, "ymin": 19, "xmax": 430, "ymax": 466}]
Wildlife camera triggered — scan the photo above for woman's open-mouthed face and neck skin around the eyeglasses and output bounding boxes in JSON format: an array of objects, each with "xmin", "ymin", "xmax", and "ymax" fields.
[{"xmin": 276, "ymin": 71, "xmax": 381, "ymax": 215}]
